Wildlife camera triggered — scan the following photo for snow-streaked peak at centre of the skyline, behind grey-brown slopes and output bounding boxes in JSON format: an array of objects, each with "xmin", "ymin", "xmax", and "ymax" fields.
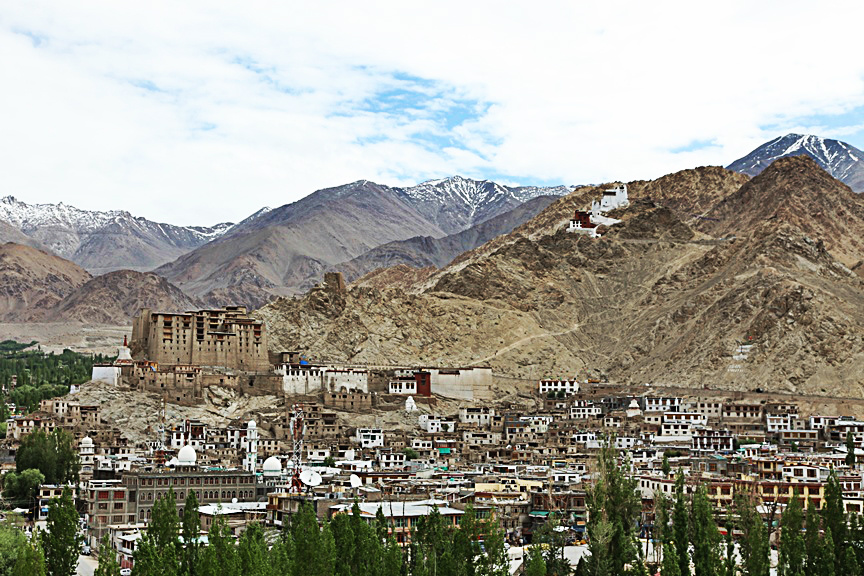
[{"xmin": 397, "ymin": 176, "xmax": 573, "ymax": 234}]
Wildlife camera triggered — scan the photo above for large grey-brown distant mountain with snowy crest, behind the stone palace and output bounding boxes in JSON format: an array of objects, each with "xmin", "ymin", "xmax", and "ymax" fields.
[{"xmin": 156, "ymin": 177, "xmax": 567, "ymax": 307}]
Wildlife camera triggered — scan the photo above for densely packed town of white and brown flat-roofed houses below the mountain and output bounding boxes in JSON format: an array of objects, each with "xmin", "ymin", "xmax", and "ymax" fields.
[{"xmin": 2, "ymin": 308, "xmax": 864, "ymax": 567}]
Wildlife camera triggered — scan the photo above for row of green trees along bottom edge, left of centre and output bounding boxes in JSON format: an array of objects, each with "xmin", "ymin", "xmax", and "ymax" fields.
[{"xmin": 116, "ymin": 491, "xmax": 509, "ymax": 576}]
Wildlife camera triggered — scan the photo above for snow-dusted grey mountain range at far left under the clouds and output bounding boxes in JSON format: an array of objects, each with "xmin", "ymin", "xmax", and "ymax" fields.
[{"xmin": 0, "ymin": 196, "xmax": 233, "ymax": 273}]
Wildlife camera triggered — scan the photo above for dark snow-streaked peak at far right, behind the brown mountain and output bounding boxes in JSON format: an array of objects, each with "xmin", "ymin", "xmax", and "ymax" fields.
[{"xmin": 728, "ymin": 134, "xmax": 864, "ymax": 192}]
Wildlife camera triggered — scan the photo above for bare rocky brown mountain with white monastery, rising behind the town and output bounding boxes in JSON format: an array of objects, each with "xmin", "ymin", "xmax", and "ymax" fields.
[{"xmin": 258, "ymin": 158, "xmax": 864, "ymax": 395}]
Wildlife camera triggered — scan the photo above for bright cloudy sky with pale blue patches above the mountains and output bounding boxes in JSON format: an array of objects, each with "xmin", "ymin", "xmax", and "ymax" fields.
[{"xmin": 0, "ymin": 0, "xmax": 864, "ymax": 225}]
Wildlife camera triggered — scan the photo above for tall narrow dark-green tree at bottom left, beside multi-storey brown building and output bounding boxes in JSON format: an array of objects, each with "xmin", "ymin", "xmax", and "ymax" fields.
[{"xmin": 42, "ymin": 488, "xmax": 82, "ymax": 576}]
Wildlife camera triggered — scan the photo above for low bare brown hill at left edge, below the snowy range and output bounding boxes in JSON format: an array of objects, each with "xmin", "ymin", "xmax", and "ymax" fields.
[{"xmin": 0, "ymin": 242, "xmax": 90, "ymax": 322}]
